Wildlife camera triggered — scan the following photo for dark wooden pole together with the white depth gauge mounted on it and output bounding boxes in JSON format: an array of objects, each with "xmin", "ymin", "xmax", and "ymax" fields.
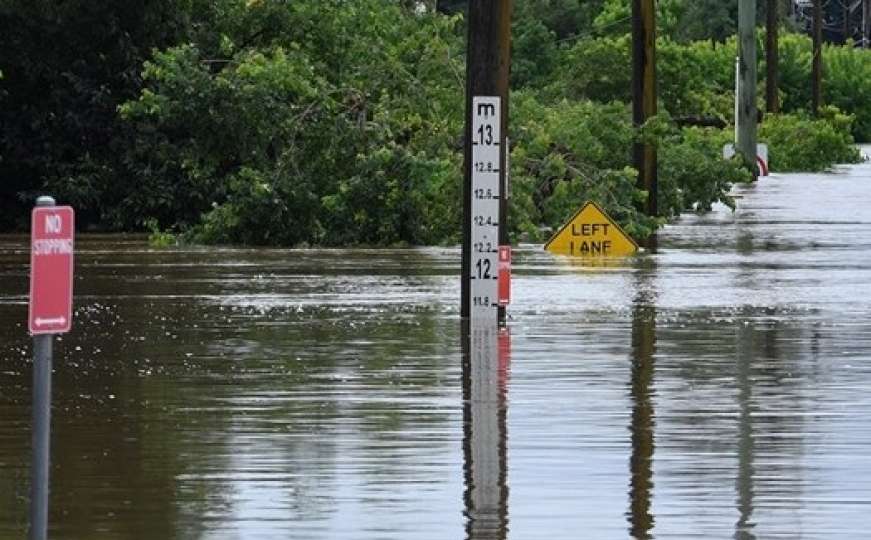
[{"xmin": 460, "ymin": 0, "xmax": 512, "ymax": 324}]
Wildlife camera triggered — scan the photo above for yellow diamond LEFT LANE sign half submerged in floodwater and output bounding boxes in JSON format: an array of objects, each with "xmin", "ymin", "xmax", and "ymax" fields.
[{"xmin": 544, "ymin": 201, "xmax": 638, "ymax": 257}]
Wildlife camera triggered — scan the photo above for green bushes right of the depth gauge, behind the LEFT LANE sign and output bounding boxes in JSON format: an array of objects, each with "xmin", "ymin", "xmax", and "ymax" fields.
[{"xmin": 511, "ymin": 95, "xmax": 751, "ymax": 239}]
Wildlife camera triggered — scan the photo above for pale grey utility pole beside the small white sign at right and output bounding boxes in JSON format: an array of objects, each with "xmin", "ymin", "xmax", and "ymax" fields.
[{"xmin": 736, "ymin": 0, "xmax": 757, "ymax": 177}]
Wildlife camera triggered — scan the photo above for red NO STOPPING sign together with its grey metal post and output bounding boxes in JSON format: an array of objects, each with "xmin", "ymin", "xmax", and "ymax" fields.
[{"xmin": 28, "ymin": 197, "xmax": 75, "ymax": 540}]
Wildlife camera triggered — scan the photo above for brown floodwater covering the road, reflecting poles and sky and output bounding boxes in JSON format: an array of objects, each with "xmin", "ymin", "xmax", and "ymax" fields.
[{"xmin": 0, "ymin": 154, "xmax": 871, "ymax": 540}]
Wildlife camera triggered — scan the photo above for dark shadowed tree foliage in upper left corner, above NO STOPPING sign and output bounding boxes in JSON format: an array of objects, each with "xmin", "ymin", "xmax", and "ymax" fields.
[{"xmin": 0, "ymin": 0, "xmax": 187, "ymax": 229}]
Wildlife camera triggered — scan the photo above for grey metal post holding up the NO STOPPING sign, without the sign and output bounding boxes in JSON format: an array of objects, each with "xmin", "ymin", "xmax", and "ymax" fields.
[{"xmin": 30, "ymin": 196, "xmax": 55, "ymax": 540}]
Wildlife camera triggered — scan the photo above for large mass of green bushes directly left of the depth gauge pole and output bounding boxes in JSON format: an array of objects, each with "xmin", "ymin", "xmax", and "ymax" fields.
[{"xmin": 116, "ymin": 0, "xmax": 462, "ymax": 245}]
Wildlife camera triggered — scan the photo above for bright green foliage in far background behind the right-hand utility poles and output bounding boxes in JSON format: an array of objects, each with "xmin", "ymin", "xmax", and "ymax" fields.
[{"xmin": 538, "ymin": 29, "xmax": 871, "ymax": 146}]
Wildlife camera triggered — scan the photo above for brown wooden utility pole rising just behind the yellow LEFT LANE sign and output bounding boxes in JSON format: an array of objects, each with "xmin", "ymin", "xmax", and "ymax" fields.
[{"xmin": 632, "ymin": 0, "xmax": 659, "ymax": 216}]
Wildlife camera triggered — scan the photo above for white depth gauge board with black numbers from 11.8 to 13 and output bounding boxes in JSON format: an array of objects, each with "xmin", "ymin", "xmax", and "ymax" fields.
[{"xmin": 466, "ymin": 96, "xmax": 502, "ymax": 325}]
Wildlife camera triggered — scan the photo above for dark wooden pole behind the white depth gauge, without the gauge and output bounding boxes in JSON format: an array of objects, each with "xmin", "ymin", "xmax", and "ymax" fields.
[{"xmin": 460, "ymin": 0, "xmax": 512, "ymax": 322}]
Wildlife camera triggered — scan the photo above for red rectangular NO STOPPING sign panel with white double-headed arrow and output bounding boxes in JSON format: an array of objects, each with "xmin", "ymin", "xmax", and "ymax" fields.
[{"xmin": 29, "ymin": 206, "xmax": 74, "ymax": 334}]
